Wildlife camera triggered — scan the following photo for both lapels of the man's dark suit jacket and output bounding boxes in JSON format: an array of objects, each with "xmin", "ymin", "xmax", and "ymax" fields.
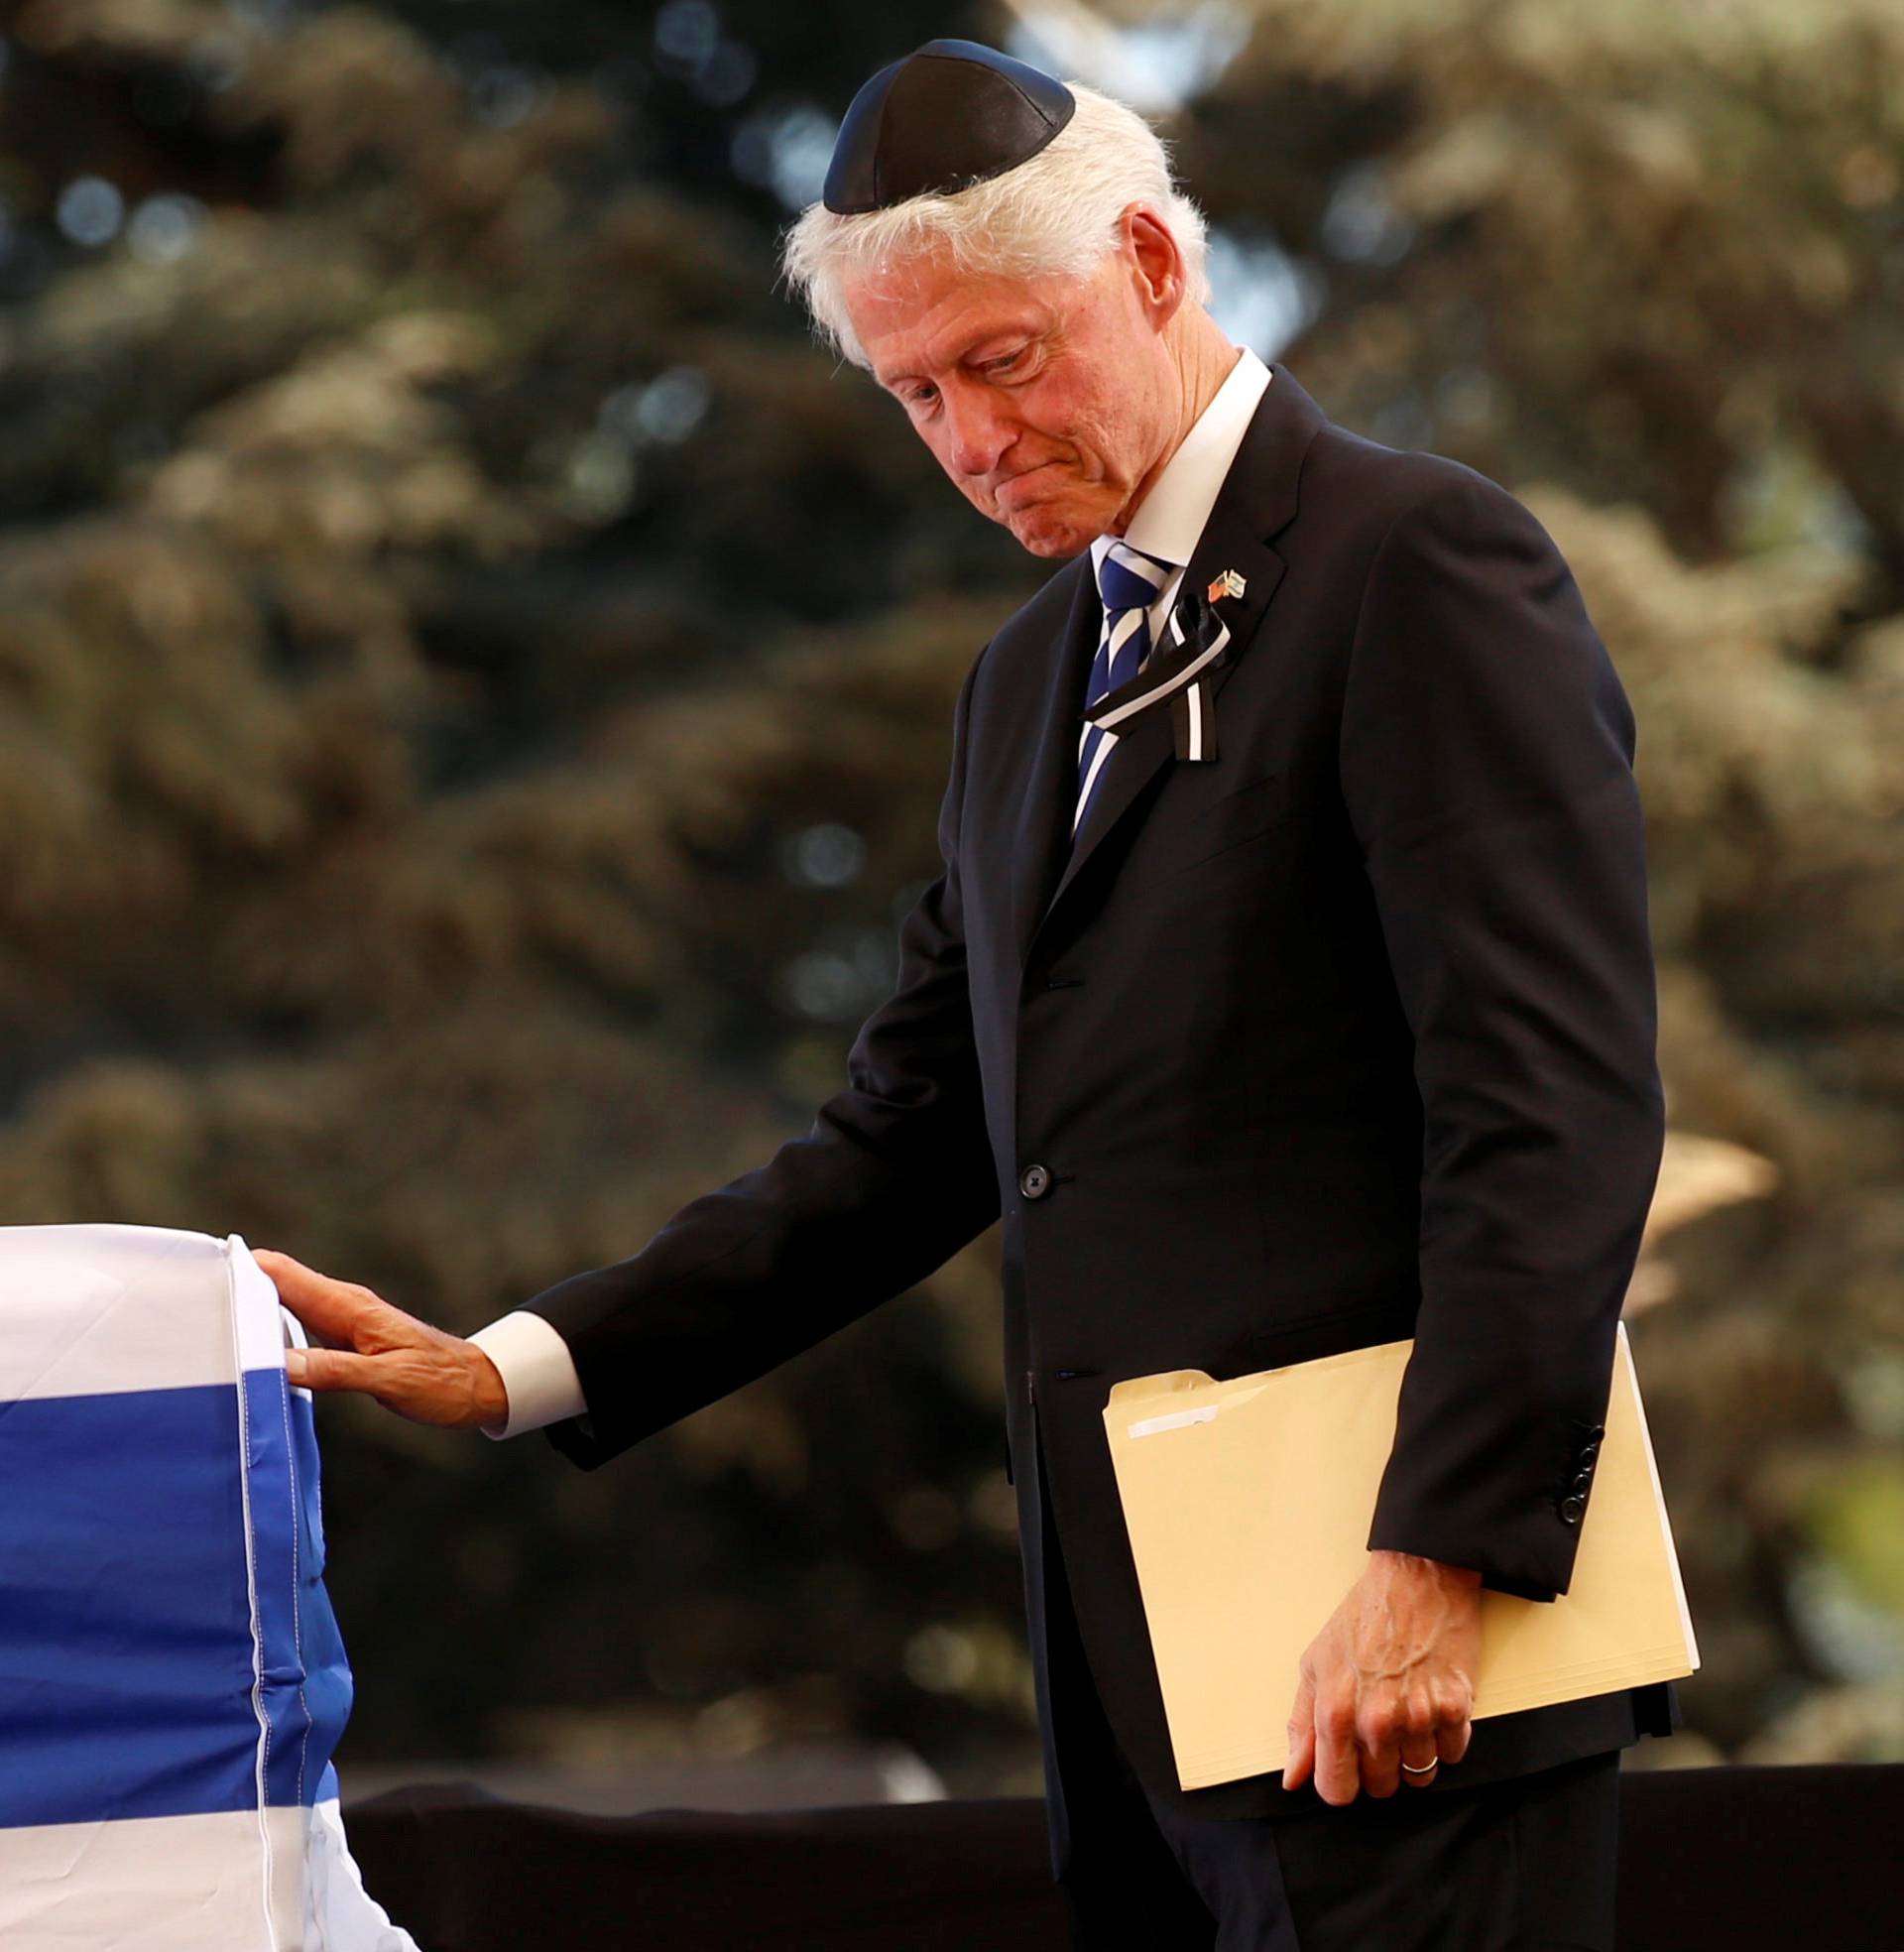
[{"xmin": 1012, "ymin": 361, "xmax": 1325, "ymax": 968}]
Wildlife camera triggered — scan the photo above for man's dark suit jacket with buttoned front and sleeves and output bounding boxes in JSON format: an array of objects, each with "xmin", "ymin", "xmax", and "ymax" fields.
[{"xmin": 529, "ymin": 365, "xmax": 1672, "ymax": 1813}]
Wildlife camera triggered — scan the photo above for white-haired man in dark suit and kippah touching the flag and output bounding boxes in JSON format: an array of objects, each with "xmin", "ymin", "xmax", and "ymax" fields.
[{"xmin": 262, "ymin": 41, "xmax": 1674, "ymax": 1952}]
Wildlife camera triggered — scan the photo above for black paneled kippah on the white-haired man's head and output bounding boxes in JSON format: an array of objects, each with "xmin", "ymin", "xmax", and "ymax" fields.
[{"xmin": 819, "ymin": 41, "xmax": 1077, "ymax": 216}]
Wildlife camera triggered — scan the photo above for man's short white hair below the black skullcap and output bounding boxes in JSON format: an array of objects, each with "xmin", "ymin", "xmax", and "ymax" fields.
[{"xmin": 780, "ymin": 82, "xmax": 1210, "ymax": 369}]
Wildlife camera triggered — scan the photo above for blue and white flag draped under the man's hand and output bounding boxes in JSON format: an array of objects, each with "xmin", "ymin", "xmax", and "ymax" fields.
[{"xmin": 0, "ymin": 1226, "xmax": 416, "ymax": 1952}]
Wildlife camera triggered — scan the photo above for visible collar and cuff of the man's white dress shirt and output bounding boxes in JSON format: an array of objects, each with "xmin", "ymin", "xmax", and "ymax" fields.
[{"xmin": 470, "ymin": 345, "xmax": 1270, "ymax": 1436}]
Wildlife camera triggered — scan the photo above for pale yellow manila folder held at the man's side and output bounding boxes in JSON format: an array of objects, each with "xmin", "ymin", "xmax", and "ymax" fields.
[{"xmin": 1104, "ymin": 1321, "xmax": 1699, "ymax": 1790}]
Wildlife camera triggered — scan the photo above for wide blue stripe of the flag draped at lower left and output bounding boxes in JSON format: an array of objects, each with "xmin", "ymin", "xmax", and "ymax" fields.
[{"xmin": 0, "ymin": 1371, "xmax": 351, "ymax": 1827}]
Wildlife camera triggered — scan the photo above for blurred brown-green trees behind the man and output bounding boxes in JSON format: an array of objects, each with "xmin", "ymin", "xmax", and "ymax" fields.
[{"xmin": 0, "ymin": 0, "xmax": 1904, "ymax": 1790}]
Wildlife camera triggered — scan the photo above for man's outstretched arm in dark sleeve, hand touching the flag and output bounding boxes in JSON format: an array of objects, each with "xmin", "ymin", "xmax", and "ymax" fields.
[{"xmin": 275, "ymin": 662, "xmax": 999, "ymax": 1466}]
